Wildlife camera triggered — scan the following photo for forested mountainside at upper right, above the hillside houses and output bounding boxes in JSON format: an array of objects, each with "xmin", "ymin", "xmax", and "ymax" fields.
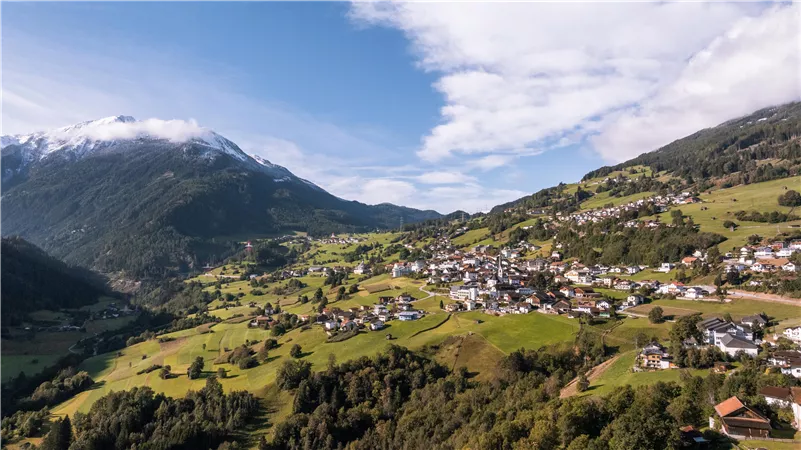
[{"xmin": 491, "ymin": 102, "xmax": 801, "ymax": 214}]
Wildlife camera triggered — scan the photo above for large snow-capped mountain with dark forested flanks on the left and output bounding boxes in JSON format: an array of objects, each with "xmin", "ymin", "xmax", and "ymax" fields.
[{"xmin": 0, "ymin": 116, "xmax": 440, "ymax": 277}]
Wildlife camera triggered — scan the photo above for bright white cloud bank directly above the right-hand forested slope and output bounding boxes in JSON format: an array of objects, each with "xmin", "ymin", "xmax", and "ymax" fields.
[{"xmin": 593, "ymin": 5, "xmax": 801, "ymax": 161}]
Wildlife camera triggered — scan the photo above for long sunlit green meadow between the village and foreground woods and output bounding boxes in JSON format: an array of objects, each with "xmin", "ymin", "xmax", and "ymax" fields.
[{"xmin": 54, "ymin": 312, "xmax": 578, "ymax": 414}]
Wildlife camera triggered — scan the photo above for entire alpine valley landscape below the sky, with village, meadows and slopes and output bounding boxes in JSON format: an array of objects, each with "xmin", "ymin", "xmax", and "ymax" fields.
[{"xmin": 0, "ymin": 105, "xmax": 801, "ymax": 450}]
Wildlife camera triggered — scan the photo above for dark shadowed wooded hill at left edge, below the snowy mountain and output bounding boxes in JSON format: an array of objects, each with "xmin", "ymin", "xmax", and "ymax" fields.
[{"xmin": 0, "ymin": 237, "xmax": 104, "ymax": 325}]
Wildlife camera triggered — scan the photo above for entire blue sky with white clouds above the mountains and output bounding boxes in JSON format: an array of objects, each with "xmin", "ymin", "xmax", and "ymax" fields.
[{"xmin": 0, "ymin": 1, "xmax": 801, "ymax": 213}]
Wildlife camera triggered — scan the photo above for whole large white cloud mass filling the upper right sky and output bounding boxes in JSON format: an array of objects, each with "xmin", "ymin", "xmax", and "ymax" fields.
[{"xmin": 351, "ymin": 1, "xmax": 798, "ymax": 163}]
